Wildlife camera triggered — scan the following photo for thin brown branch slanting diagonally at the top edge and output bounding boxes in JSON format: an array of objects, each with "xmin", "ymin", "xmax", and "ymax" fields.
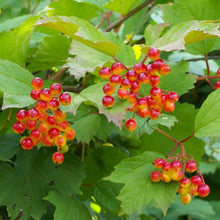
[{"xmin": 104, "ymin": 0, "xmax": 155, "ymax": 31}]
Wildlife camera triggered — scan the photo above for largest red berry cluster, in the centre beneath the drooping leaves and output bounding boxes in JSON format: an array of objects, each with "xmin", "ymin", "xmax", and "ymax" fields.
[{"xmin": 99, "ymin": 48, "xmax": 179, "ymax": 131}]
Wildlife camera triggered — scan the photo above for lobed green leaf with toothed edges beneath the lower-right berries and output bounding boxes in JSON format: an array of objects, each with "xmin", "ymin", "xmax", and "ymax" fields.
[{"xmin": 107, "ymin": 151, "xmax": 178, "ymax": 214}]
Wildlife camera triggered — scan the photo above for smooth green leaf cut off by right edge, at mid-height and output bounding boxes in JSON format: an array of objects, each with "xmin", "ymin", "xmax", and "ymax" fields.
[{"xmin": 194, "ymin": 89, "xmax": 220, "ymax": 137}]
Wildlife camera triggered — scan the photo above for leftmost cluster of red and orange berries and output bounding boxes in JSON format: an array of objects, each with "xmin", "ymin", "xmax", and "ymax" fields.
[{"xmin": 13, "ymin": 77, "xmax": 75, "ymax": 164}]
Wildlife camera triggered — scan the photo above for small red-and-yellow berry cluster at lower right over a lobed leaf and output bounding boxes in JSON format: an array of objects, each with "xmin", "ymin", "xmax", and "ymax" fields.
[{"xmin": 151, "ymin": 158, "xmax": 210, "ymax": 204}]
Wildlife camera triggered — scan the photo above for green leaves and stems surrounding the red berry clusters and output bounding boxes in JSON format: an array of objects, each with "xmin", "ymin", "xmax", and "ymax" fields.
[{"xmin": 0, "ymin": 0, "xmax": 220, "ymax": 220}]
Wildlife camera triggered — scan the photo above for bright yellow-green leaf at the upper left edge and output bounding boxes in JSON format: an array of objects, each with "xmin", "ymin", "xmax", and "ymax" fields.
[{"xmin": 0, "ymin": 16, "xmax": 39, "ymax": 66}]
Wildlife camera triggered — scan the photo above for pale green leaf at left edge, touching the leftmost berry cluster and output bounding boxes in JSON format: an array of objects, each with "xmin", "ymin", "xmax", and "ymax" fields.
[{"xmin": 0, "ymin": 60, "xmax": 34, "ymax": 109}]
